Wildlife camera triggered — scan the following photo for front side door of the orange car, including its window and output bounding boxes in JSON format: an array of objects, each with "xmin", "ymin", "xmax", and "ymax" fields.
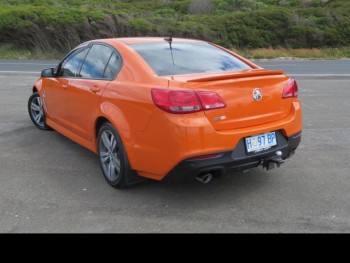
[{"xmin": 43, "ymin": 46, "xmax": 89, "ymax": 129}]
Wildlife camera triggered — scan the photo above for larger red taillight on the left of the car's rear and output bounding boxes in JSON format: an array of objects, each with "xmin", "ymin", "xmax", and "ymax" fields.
[{"xmin": 152, "ymin": 89, "xmax": 226, "ymax": 114}]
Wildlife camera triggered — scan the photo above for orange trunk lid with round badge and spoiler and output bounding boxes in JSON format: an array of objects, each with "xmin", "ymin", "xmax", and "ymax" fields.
[{"xmin": 169, "ymin": 69, "xmax": 292, "ymax": 131}]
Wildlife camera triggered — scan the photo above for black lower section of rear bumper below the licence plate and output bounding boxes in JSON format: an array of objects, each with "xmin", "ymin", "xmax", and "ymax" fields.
[{"xmin": 164, "ymin": 131, "xmax": 301, "ymax": 181}]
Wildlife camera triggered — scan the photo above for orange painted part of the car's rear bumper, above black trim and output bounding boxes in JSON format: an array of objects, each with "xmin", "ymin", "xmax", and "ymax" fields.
[{"xmin": 125, "ymin": 101, "xmax": 302, "ymax": 180}]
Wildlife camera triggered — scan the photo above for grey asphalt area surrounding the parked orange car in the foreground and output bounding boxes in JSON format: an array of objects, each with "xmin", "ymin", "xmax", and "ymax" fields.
[{"xmin": 0, "ymin": 62, "xmax": 350, "ymax": 233}]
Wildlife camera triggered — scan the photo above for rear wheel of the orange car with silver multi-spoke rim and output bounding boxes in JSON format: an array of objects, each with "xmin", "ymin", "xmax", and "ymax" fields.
[{"xmin": 98, "ymin": 122, "xmax": 134, "ymax": 188}]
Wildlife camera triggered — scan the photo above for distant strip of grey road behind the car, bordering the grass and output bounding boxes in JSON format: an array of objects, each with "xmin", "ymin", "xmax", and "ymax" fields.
[{"xmin": 0, "ymin": 59, "xmax": 350, "ymax": 76}]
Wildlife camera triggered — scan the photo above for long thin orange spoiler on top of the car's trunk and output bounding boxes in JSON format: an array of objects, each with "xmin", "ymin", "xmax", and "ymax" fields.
[{"xmin": 183, "ymin": 69, "xmax": 284, "ymax": 82}]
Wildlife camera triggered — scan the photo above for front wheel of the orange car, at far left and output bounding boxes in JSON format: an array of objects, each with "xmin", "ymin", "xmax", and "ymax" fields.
[{"xmin": 28, "ymin": 92, "xmax": 51, "ymax": 131}]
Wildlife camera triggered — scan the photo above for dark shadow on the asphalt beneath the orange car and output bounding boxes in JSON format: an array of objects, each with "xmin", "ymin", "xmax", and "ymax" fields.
[{"xmin": 26, "ymin": 127, "xmax": 276, "ymax": 208}]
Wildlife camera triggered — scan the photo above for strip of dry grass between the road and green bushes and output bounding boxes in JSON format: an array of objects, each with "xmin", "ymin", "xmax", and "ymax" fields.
[{"xmin": 0, "ymin": 44, "xmax": 350, "ymax": 59}]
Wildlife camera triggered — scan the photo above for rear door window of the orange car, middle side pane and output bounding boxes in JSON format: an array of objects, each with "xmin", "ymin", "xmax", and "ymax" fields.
[{"xmin": 80, "ymin": 45, "xmax": 113, "ymax": 79}]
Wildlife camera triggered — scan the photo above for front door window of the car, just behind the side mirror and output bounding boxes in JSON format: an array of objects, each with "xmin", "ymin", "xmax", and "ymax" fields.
[{"xmin": 59, "ymin": 47, "xmax": 89, "ymax": 78}]
